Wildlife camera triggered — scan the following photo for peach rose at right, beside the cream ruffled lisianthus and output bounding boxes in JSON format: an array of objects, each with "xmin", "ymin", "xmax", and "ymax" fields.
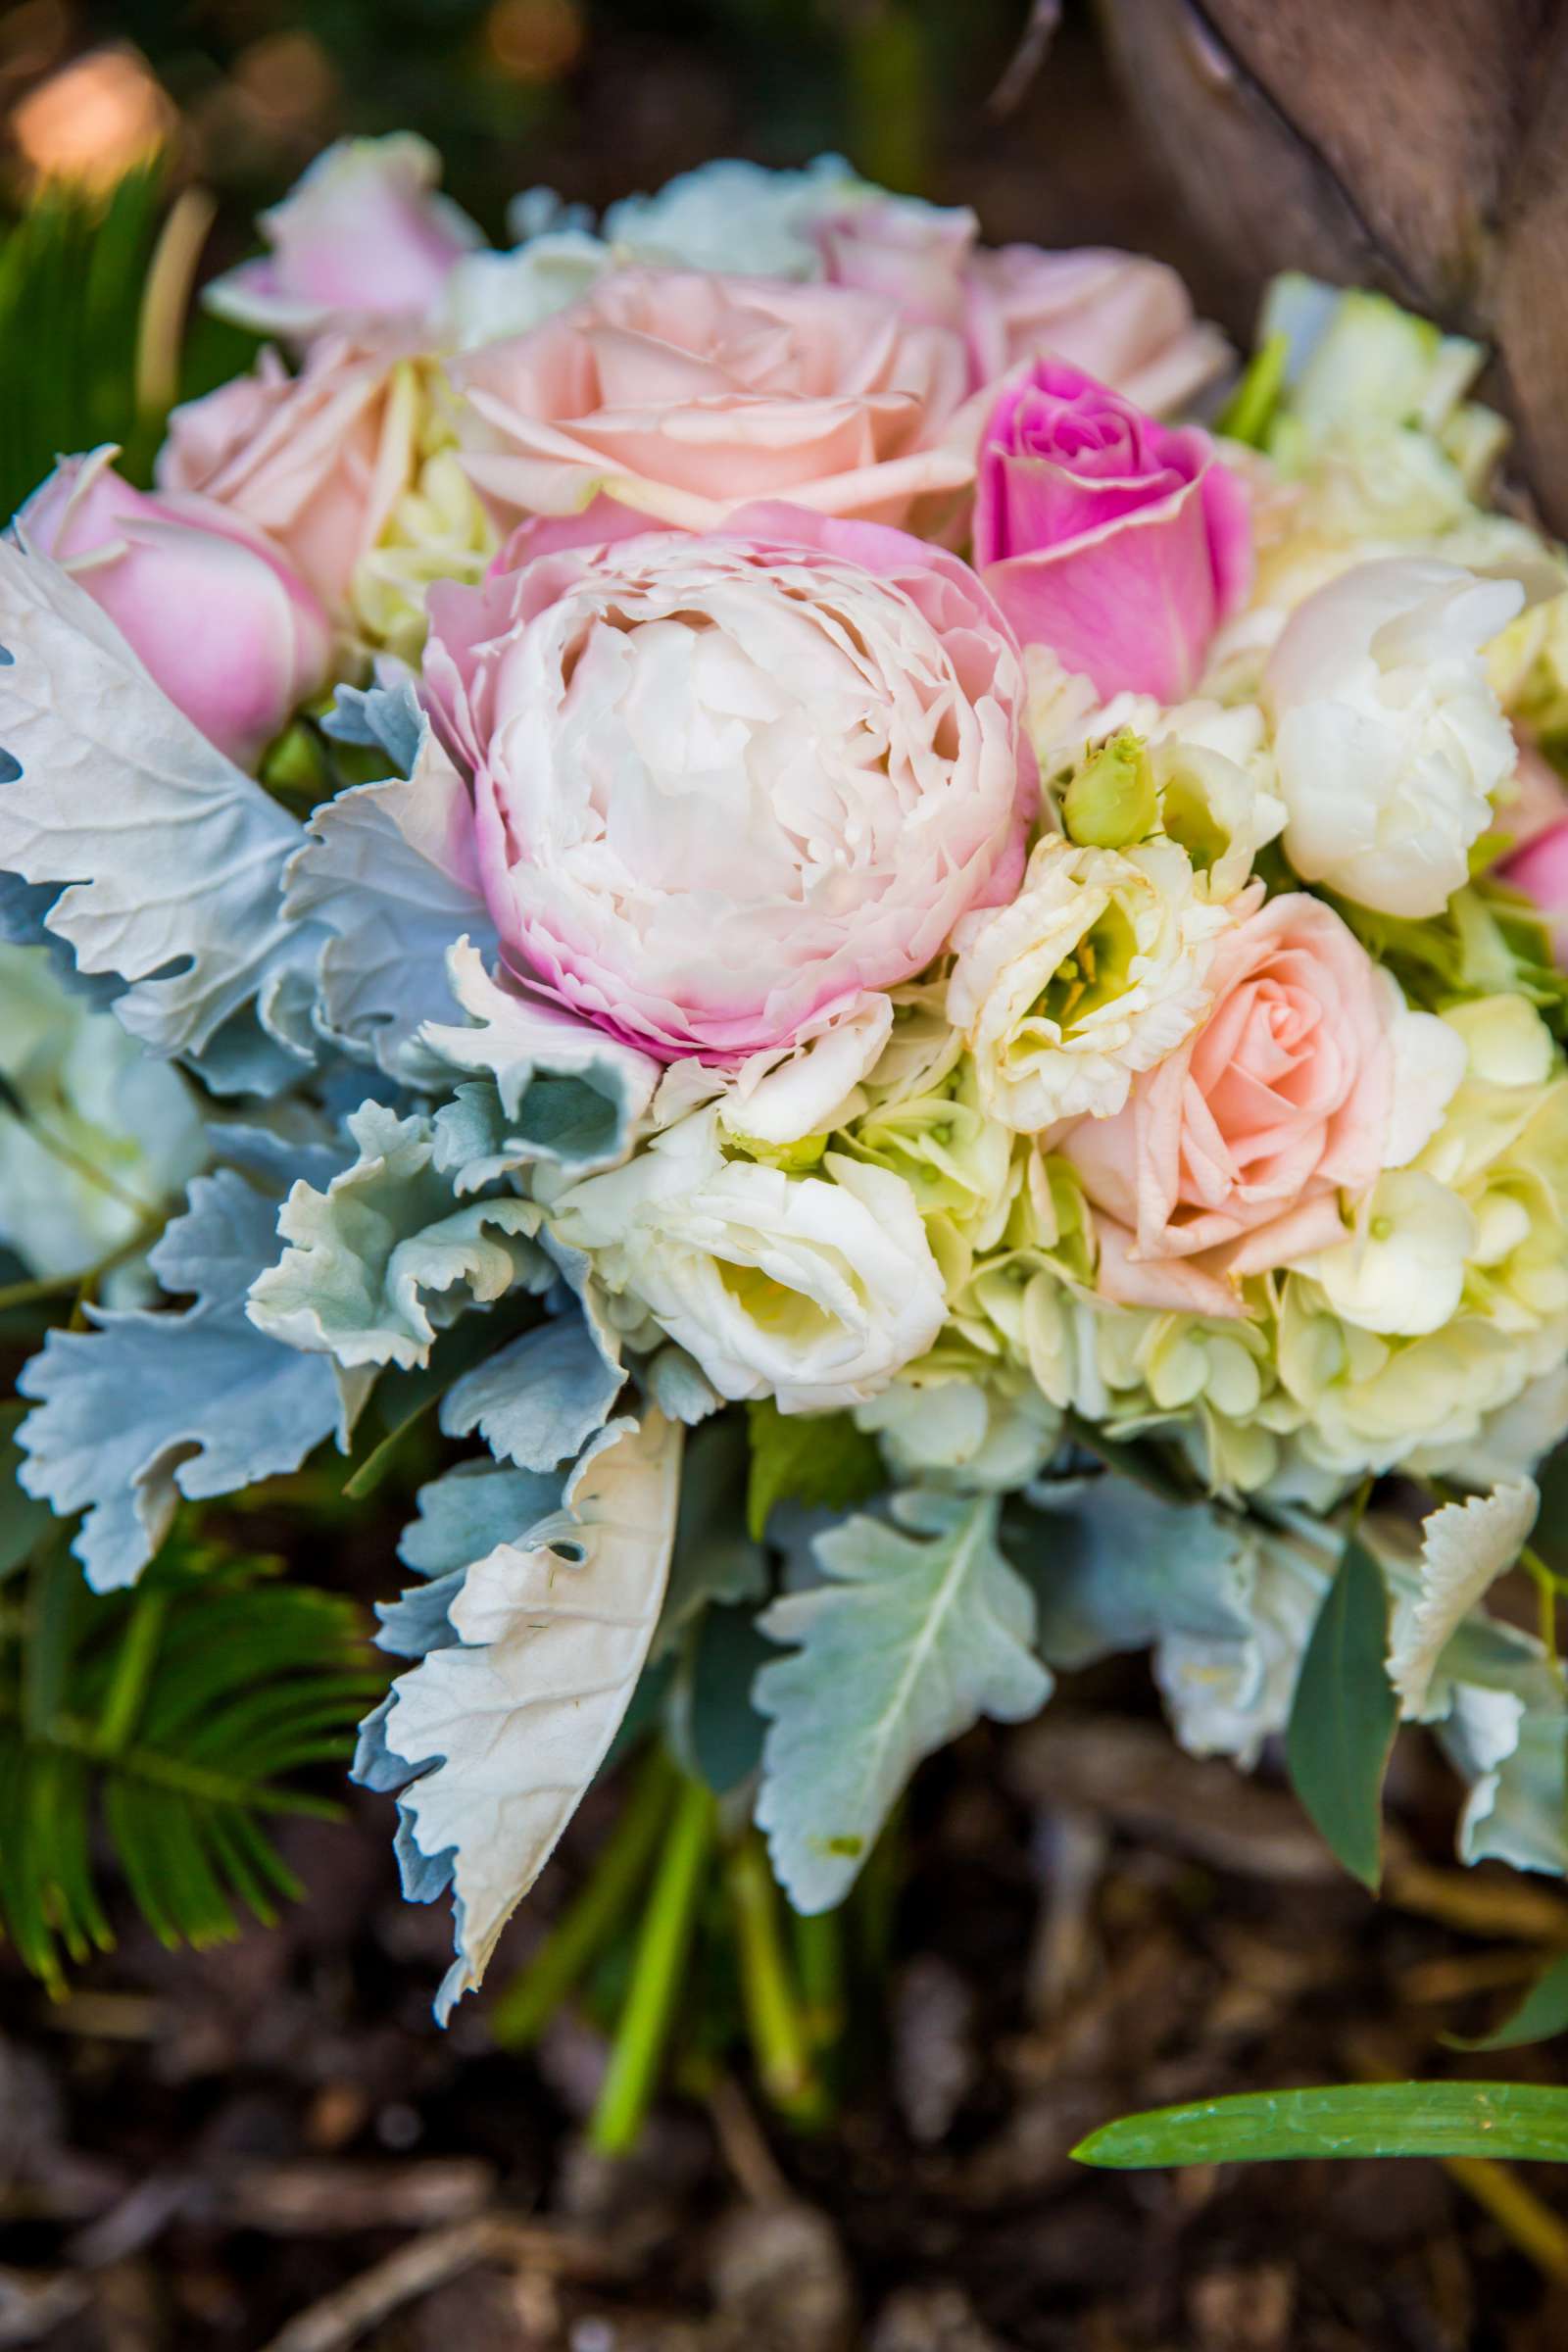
[{"xmin": 1060, "ymin": 892, "xmax": 1425, "ymax": 1315}]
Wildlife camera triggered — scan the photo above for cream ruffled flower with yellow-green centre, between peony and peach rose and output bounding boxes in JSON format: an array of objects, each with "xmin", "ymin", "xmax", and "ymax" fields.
[{"xmin": 948, "ymin": 837, "xmax": 1234, "ymax": 1134}]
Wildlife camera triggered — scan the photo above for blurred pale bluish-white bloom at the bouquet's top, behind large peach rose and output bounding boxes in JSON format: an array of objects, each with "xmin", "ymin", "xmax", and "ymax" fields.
[{"xmin": 602, "ymin": 155, "xmax": 877, "ymax": 277}]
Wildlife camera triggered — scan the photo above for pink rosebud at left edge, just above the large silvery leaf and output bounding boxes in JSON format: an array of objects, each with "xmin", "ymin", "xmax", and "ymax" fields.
[{"xmin": 17, "ymin": 449, "xmax": 331, "ymax": 766}]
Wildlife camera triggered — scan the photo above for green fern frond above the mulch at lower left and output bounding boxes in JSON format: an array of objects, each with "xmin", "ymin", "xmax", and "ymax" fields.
[{"xmin": 0, "ymin": 1531, "xmax": 381, "ymax": 1989}]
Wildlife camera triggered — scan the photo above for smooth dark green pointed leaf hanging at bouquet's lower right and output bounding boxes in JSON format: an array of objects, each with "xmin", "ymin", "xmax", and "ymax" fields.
[{"xmin": 1286, "ymin": 1536, "xmax": 1398, "ymax": 1893}]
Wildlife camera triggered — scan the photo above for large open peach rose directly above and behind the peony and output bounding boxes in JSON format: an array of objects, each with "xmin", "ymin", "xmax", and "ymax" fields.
[{"xmin": 452, "ymin": 270, "xmax": 980, "ymax": 531}]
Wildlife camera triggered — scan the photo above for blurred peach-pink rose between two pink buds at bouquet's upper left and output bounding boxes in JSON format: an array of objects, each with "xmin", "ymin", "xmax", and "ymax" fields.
[{"xmin": 158, "ymin": 336, "xmax": 414, "ymax": 616}]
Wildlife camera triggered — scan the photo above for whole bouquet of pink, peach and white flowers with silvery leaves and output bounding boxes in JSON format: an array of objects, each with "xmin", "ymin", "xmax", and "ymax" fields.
[{"xmin": 0, "ymin": 139, "xmax": 1568, "ymax": 2154}]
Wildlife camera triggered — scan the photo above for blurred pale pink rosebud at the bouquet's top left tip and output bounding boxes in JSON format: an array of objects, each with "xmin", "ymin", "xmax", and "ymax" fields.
[{"xmin": 202, "ymin": 131, "xmax": 484, "ymax": 343}]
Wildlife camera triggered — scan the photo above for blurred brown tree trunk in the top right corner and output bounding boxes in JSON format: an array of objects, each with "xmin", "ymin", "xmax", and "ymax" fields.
[{"xmin": 1098, "ymin": 0, "xmax": 1568, "ymax": 529}]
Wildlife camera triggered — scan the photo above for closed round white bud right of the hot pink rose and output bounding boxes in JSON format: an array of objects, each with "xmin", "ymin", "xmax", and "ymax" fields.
[{"xmin": 1262, "ymin": 558, "xmax": 1523, "ymax": 919}]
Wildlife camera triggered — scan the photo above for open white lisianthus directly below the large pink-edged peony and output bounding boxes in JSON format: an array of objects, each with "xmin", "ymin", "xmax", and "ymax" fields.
[{"xmin": 550, "ymin": 1110, "xmax": 945, "ymax": 1413}]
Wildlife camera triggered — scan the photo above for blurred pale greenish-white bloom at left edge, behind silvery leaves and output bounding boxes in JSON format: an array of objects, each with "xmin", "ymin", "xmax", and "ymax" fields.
[{"xmin": 0, "ymin": 946, "xmax": 207, "ymax": 1298}]
